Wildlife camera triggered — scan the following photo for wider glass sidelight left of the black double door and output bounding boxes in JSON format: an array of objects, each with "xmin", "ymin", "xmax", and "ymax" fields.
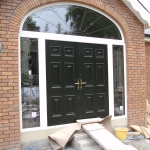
[{"xmin": 21, "ymin": 38, "xmax": 40, "ymax": 128}]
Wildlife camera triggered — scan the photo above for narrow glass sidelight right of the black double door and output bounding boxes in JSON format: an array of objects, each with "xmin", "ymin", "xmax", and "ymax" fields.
[{"xmin": 113, "ymin": 46, "xmax": 125, "ymax": 116}]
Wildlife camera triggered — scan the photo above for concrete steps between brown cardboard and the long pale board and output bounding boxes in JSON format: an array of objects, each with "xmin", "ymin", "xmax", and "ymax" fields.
[{"xmin": 70, "ymin": 131, "xmax": 103, "ymax": 150}]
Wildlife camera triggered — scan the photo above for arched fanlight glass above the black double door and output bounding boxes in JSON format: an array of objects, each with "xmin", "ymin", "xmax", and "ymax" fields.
[{"xmin": 23, "ymin": 5, "xmax": 121, "ymax": 40}]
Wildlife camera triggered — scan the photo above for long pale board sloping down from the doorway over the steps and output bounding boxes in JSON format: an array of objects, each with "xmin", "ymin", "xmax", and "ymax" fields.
[{"xmin": 82, "ymin": 123, "xmax": 135, "ymax": 150}]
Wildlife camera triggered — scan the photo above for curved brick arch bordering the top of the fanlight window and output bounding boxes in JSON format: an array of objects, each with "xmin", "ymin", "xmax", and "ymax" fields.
[{"xmin": 9, "ymin": 0, "xmax": 132, "ymax": 42}]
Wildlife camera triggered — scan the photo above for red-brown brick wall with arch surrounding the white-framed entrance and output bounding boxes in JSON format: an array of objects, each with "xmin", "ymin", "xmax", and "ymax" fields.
[{"xmin": 0, "ymin": 0, "xmax": 147, "ymax": 150}]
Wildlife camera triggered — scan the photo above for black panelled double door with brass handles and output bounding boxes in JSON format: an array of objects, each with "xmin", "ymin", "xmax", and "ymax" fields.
[{"xmin": 46, "ymin": 40, "xmax": 109, "ymax": 126}]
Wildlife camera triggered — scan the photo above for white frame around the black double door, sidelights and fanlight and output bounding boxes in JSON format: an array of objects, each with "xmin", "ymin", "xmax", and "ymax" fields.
[{"xmin": 18, "ymin": 2, "xmax": 127, "ymax": 132}]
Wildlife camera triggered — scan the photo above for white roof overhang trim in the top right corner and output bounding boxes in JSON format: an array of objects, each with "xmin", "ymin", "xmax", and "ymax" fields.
[{"xmin": 122, "ymin": 0, "xmax": 150, "ymax": 28}]
